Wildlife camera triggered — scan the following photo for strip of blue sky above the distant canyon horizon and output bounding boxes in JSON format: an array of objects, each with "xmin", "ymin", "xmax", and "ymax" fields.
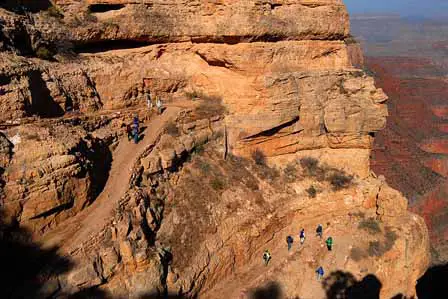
[{"xmin": 344, "ymin": 0, "xmax": 448, "ymax": 17}]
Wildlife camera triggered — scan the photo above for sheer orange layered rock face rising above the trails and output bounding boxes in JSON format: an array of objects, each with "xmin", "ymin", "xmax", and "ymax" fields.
[{"xmin": 2, "ymin": 1, "xmax": 387, "ymax": 177}]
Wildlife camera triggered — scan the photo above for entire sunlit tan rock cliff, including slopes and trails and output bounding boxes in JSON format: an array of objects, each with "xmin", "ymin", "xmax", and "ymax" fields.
[{"xmin": 0, "ymin": 0, "xmax": 429, "ymax": 298}]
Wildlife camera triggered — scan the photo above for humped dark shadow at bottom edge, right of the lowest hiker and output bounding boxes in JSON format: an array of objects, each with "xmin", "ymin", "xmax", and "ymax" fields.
[{"xmin": 322, "ymin": 271, "xmax": 382, "ymax": 299}]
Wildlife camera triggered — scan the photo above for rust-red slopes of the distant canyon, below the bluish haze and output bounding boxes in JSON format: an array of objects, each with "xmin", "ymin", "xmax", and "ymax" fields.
[{"xmin": 366, "ymin": 57, "xmax": 448, "ymax": 261}]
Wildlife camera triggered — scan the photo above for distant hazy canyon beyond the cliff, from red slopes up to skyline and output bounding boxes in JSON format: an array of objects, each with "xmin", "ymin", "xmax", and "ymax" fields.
[{"xmin": 352, "ymin": 16, "xmax": 448, "ymax": 264}]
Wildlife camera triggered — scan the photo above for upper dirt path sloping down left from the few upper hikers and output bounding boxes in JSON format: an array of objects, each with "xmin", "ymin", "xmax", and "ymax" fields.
[{"xmin": 40, "ymin": 107, "xmax": 181, "ymax": 253}]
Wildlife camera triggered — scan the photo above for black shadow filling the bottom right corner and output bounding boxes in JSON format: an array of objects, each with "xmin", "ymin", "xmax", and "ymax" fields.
[{"xmin": 417, "ymin": 264, "xmax": 448, "ymax": 299}]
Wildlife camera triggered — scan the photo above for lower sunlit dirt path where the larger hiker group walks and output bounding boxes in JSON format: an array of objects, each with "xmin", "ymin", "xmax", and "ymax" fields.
[{"xmin": 200, "ymin": 219, "xmax": 352, "ymax": 299}]
